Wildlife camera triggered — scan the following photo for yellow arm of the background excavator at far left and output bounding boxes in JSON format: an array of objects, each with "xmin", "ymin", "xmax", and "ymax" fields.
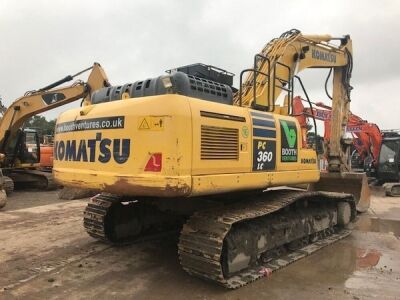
[{"xmin": 0, "ymin": 63, "xmax": 109, "ymax": 159}]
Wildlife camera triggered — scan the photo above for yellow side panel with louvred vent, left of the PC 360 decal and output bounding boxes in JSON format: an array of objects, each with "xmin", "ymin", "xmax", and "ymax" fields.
[{"xmin": 190, "ymin": 99, "xmax": 251, "ymax": 175}]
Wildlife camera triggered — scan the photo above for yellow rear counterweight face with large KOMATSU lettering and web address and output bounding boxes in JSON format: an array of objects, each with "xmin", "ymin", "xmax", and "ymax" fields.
[{"xmin": 54, "ymin": 95, "xmax": 192, "ymax": 193}]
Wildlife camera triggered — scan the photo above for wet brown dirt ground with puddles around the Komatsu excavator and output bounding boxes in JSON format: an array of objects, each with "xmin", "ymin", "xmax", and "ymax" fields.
[{"xmin": 0, "ymin": 188, "xmax": 400, "ymax": 299}]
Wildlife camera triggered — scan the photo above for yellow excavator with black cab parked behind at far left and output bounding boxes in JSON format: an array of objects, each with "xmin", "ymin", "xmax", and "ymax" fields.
[{"xmin": 0, "ymin": 63, "xmax": 108, "ymax": 208}]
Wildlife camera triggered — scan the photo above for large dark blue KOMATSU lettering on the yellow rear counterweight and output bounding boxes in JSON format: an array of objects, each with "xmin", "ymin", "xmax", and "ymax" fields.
[{"xmin": 54, "ymin": 133, "xmax": 131, "ymax": 164}]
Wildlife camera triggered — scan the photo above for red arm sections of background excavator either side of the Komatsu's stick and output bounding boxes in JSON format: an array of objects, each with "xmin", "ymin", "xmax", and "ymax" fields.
[{"xmin": 293, "ymin": 96, "xmax": 382, "ymax": 174}]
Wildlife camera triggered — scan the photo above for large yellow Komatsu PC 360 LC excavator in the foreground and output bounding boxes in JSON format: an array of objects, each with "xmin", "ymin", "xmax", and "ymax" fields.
[{"xmin": 53, "ymin": 30, "xmax": 369, "ymax": 288}]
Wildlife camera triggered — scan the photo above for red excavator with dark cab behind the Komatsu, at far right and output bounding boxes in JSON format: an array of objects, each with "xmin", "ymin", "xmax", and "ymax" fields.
[{"xmin": 293, "ymin": 96, "xmax": 400, "ymax": 196}]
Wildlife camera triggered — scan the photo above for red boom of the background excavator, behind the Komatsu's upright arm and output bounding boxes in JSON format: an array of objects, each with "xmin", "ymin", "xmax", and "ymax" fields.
[{"xmin": 293, "ymin": 96, "xmax": 382, "ymax": 167}]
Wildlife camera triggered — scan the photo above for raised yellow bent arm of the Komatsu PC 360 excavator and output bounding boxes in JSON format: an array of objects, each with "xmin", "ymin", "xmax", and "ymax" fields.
[{"xmin": 235, "ymin": 30, "xmax": 352, "ymax": 172}]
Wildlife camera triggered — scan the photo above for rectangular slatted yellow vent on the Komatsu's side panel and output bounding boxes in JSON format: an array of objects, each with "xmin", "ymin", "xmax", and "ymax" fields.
[{"xmin": 201, "ymin": 125, "xmax": 239, "ymax": 160}]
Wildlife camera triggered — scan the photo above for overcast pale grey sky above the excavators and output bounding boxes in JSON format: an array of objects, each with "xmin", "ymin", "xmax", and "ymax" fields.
[{"xmin": 0, "ymin": 0, "xmax": 400, "ymax": 129}]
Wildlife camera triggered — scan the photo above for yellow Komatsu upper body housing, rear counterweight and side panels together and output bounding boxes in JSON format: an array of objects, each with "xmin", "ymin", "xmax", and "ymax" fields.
[{"xmin": 53, "ymin": 94, "xmax": 319, "ymax": 197}]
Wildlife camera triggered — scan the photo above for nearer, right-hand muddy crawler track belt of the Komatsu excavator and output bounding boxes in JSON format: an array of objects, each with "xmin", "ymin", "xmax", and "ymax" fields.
[{"xmin": 178, "ymin": 191, "xmax": 356, "ymax": 289}]
